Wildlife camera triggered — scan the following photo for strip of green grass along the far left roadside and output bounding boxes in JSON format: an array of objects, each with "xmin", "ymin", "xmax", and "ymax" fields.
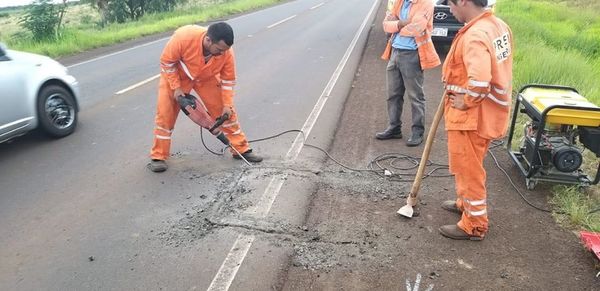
[{"xmin": 0, "ymin": 0, "xmax": 281, "ymax": 57}]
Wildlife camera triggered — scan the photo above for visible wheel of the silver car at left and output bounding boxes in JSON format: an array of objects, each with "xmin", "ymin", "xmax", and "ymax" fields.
[{"xmin": 37, "ymin": 85, "xmax": 77, "ymax": 138}]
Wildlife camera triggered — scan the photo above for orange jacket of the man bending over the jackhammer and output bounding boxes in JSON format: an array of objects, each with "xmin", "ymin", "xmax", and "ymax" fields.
[{"xmin": 160, "ymin": 25, "xmax": 235, "ymax": 107}]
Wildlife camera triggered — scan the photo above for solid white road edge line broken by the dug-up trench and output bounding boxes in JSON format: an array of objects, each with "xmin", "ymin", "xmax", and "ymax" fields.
[{"xmin": 208, "ymin": 1, "xmax": 379, "ymax": 291}]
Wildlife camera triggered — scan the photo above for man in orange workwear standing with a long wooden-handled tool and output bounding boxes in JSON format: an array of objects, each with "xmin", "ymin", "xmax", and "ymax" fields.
[{"xmin": 439, "ymin": 0, "xmax": 513, "ymax": 240}]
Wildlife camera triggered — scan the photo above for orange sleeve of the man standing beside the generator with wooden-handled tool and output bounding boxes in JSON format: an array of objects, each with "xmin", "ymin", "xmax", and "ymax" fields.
[{"xmin": 462, "ymin": 31, "xmax": 493, "ymax": 108}]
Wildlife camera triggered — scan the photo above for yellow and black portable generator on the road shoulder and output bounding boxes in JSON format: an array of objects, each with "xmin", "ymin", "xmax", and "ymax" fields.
[{"xmin": 507, "ymin": 84, "xmax": 600, "ymax": 190}]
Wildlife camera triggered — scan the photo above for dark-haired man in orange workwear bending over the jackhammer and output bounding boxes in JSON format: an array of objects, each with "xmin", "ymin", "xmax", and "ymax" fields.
[{"xmin": 148, "ymin": 22, "xmax": 262, "ymax": 172}]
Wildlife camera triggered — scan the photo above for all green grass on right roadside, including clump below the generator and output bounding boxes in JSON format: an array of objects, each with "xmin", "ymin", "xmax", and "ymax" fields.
[{"xmin": 496, "ymin": 0, "xmax": 600, "ymax": 232}]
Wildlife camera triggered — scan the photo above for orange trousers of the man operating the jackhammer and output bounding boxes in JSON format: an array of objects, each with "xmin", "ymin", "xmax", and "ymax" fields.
[{"xmin": 150, "ymin": 77, "xmax": 250, "ymax": 160}]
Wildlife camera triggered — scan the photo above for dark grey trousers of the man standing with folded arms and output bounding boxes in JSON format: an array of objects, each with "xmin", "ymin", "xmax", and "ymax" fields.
[{"xmin": 387, "ymin": 49, "xmax": 425, "ymax": 134}]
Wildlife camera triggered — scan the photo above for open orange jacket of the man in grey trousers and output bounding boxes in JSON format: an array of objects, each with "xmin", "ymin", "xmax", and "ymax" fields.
[{"xmin": 381, "ymin": 0, "xmax": 441, "ymax": 70}]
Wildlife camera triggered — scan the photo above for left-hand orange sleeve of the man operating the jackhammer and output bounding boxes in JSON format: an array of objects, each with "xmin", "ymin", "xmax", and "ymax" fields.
[{"xmin": 160, "ymin": 31, "xmax": 182, "ymax": 90}]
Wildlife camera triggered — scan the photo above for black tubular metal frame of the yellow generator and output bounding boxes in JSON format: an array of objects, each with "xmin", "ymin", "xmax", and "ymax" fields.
[{"xmin": 507, "ymin": 84, "xmax": 600, "ymax": 190}]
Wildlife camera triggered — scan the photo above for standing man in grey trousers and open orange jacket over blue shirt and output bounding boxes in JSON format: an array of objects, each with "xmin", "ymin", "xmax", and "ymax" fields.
[{"xmin": 375, "ymin": 0, "xmax": 441, "ymax": 146}]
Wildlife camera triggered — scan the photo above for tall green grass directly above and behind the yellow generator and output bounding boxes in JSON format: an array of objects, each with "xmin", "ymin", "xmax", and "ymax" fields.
[{"xmin": 496, "ymin": 0, "xmax": 600, "ymax": 105}]
